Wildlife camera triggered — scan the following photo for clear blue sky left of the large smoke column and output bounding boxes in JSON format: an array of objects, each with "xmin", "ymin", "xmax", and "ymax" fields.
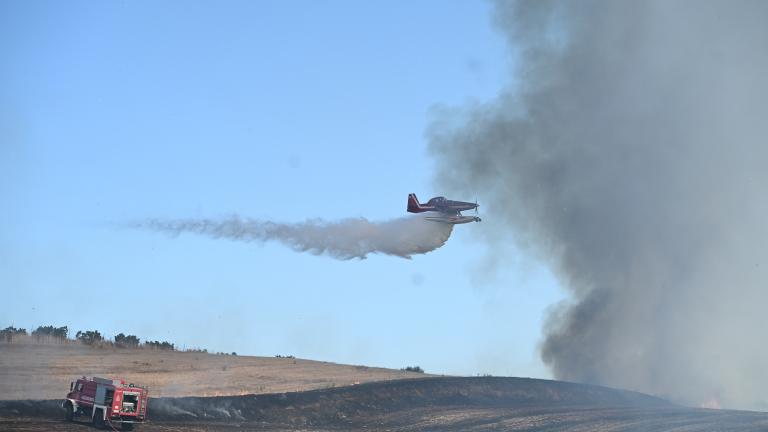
[{"xmin": 0, "ymin": 1, "xmax": 563, "ymax": 377}]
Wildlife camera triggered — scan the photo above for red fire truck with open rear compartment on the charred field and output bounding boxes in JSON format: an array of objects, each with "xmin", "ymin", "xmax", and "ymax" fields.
[{"xmin": 62, "ymin": 377, "xmax": 149, "ymax": 430}]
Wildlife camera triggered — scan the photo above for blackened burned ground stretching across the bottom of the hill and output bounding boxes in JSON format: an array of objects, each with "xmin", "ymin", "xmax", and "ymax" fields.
[{"xmin": 0, "ymin": 377, "xmax": 768, "ymax": 431}]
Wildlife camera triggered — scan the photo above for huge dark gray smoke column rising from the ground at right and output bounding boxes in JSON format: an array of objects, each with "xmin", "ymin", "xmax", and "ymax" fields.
[{"xmin": 429, "ymin": 0, "xmax": 768, "ymax": 410}]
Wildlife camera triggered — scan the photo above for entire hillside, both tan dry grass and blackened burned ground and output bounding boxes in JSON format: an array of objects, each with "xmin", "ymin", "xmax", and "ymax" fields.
[{"xmin": 0, "ymin": 339, "xmax": 768, "ymax": 432}]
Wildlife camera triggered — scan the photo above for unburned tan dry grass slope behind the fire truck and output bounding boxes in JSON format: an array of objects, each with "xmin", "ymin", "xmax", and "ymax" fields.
[{"xmin": 0, "ymin": 338, "xmax": 424, "ymax": 400}]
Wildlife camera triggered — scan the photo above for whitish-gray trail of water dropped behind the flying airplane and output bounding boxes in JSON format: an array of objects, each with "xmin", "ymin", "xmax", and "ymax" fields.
[{"xmin": 135, "ymin": 216, "xmax": 453, "ymax": 260}]
